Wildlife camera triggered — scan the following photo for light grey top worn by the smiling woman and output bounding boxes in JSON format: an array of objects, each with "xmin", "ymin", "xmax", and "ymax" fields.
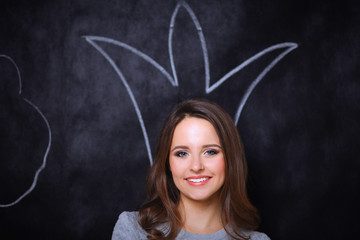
[{"xmin": 111, "ymin": 212, "xmax": 270, "ymax": 240}]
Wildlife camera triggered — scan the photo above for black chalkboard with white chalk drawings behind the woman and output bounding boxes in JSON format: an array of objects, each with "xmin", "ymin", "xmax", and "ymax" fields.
[{"xmin": 0, "ymin": 0, "xmax": 360, "ymax": 239}]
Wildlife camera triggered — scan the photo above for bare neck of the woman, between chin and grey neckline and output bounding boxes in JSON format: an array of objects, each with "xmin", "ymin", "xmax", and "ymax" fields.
[{"xmin": 179, "ymin": 196, "xmax": 224, "ymax": 234}]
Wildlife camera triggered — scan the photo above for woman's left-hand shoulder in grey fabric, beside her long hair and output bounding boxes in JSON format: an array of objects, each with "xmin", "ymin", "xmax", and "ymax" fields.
[{"xmin": 111, "ymin": 212, "xmax": 146, "ymax": 240}]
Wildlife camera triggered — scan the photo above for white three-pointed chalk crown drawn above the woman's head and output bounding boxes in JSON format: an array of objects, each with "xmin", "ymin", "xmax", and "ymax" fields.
[{"xmin": 84, "ymin": 0, "xmax": 298, "ymax": 165}]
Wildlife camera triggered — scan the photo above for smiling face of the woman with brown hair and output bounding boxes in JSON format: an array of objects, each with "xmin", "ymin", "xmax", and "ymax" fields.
[{"xmin": 169, "ymin": 117, "xmax": 225, "ymax": 201}]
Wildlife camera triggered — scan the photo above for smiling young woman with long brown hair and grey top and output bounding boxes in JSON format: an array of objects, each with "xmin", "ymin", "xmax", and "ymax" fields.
[{"xmin": 112, "ymin": 99, "xmax": 269, "ymax": 240}]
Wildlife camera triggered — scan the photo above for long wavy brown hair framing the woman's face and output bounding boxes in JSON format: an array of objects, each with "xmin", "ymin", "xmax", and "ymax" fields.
[{"xmin": 139, "ymin": 99, "xmax": 260, "ymax": 239}]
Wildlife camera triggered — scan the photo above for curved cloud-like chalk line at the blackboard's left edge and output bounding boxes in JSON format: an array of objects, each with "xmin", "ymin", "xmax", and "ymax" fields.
[{"xmin": 0, "ymin": 54, "xmax": 51, "ymax": 207}]
